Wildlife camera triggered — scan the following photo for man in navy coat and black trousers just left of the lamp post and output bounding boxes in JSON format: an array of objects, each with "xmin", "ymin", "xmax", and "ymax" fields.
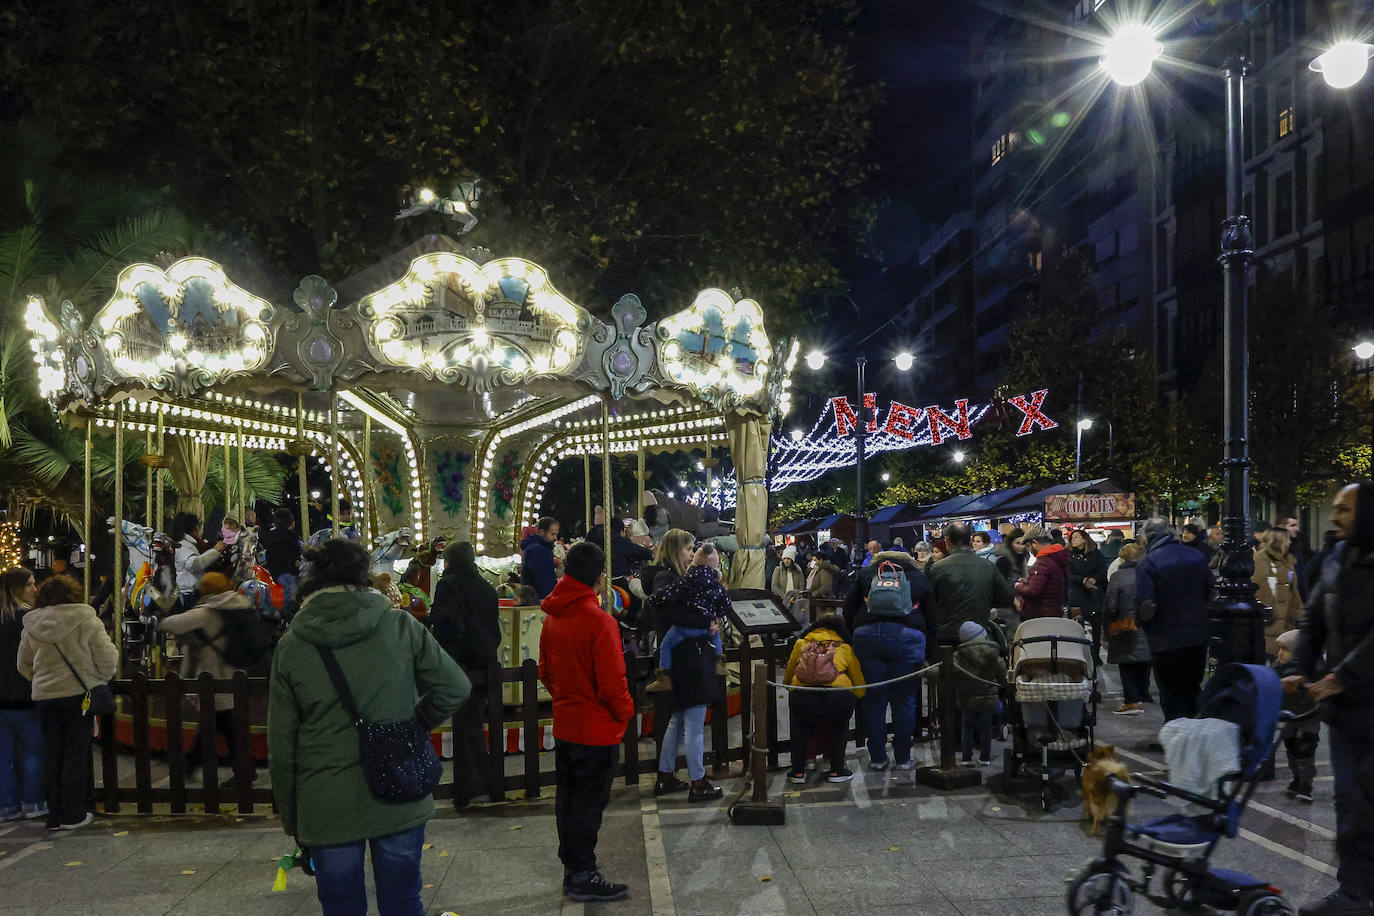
[{"xmin": 1135, "ymin": 516, "xmax": 1216, "ymax": 721}]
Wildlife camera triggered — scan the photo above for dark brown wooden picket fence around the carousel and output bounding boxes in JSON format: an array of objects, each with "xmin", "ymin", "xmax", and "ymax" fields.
[{"xmin": 96, "ymin": 639, "xmax": 790, "ymax": 814}]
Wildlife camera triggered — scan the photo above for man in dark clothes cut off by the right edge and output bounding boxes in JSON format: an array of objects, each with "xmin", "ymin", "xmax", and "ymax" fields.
[{"xmin": 1283, "ymin": 482, "xmax": 1374, "ymax": 916}]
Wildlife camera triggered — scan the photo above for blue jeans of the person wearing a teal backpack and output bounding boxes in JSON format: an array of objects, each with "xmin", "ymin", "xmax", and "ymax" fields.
[{"xmin": 853, "ymin": 622, "xmax": 926, "ymax": 764}]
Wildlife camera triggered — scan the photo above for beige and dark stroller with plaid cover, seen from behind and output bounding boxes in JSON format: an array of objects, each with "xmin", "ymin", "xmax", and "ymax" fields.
[{"xmin": 1002, "ymin": 617, "xmax": 1098, "ymax": 810}]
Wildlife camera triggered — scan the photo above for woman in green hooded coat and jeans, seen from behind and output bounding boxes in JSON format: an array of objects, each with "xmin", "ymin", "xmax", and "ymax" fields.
[{"xmin": 267, "ymin": 540, "xmax": 471, "ymax": 916}]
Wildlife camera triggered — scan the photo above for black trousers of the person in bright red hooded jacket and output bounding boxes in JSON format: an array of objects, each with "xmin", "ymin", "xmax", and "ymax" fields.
[{"xmin": 554, "ymin": 740, "xmax": 620, "ymax": 876}]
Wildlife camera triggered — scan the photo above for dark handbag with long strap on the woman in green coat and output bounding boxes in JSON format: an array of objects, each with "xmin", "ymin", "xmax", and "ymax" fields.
[{"xmin": 315, "ymin": 645, "xmax": 444, "ymax": 805}]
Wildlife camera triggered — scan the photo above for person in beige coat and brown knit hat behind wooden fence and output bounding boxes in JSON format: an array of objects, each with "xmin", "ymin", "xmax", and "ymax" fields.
[{"xmin": 162, "ymin": 573, "xmax": 253, "ymax": 788}]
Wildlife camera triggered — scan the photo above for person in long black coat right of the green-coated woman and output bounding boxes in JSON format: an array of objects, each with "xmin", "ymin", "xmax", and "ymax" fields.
[{"xmin": 430, "ymin": 541, "xmax": 502, "ymax": 808}]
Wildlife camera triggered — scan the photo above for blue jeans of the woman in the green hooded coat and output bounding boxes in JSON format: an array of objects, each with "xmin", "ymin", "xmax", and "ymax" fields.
[{"xmin": 311, "ymin": 824, "xmax": 425, "ymax": 916}]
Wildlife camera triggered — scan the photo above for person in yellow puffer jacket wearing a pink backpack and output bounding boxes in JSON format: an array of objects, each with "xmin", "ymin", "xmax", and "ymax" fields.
[{"xmin": 782, "ymin": 614, "xmax": 864, "ymax": 783}]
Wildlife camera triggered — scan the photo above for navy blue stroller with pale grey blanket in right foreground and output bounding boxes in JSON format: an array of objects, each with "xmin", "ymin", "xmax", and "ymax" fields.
[{"xmin": 1068, "ymin": 665, "xmax": 1316, "ymax": 916}]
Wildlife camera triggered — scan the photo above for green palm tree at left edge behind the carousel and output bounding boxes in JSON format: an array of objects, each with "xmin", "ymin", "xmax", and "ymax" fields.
[{"xmin": 0, "ymin": 124, "xmax": 284, "ymax": 537}]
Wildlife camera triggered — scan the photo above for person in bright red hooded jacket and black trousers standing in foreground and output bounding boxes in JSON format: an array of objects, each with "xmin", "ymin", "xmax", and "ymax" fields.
[{"xmin": 539, "ymin": 542, "xmax": 635, "ymax": 904}]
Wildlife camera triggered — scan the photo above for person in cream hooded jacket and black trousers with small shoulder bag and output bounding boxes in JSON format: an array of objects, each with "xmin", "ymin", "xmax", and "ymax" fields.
[{"xmin": 15, "ymin": 575, "xmax": 120, "ymax": 829}]
